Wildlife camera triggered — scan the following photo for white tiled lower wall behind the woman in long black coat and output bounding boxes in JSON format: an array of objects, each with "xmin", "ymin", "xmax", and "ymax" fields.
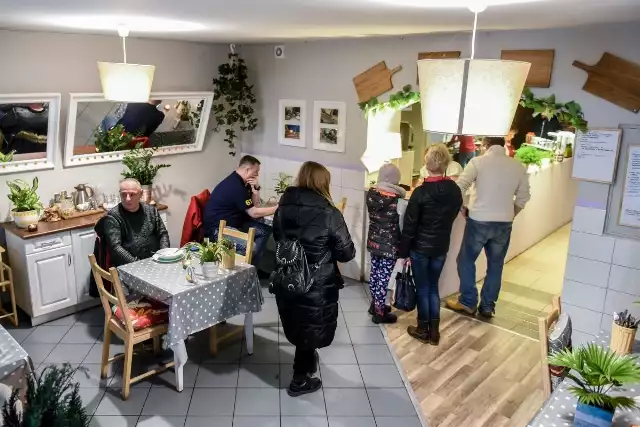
[{"xmin": 247, "ymin": 153, "xmax": 365, "ymax": 280}]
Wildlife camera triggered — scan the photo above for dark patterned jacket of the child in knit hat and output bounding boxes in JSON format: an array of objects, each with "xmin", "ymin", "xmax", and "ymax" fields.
[{"xmin": 367, "ymin": 188, "xmax": 400, "ymax": 258}]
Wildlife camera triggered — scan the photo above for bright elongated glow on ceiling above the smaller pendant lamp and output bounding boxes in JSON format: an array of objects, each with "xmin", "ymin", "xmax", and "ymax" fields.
[{"xmin": 38, "ymin": 15, "xmax": 207, "ymax": 33}]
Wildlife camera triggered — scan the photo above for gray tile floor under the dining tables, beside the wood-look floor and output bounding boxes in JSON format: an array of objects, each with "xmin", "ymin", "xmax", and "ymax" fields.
[{"xmin": 5, "ymin": 283, "xmax": 421, "ymax": 427}]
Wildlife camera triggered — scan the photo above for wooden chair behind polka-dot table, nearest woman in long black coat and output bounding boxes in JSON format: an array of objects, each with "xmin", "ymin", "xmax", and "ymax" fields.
[{"xmin": 209, "ymin": 220, "xmax": 256, "ymax": 356}]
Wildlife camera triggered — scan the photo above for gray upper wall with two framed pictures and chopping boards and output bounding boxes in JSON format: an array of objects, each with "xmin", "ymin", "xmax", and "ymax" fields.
[{"xmin": 243, "ymin": 23, "xmax": 640, "ymax": 168}]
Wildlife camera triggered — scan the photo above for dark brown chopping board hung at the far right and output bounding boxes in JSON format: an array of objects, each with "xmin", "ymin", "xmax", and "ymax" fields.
[{"xmin": 573, "ymin": 52, "xmax": 640, "ymax": 113}]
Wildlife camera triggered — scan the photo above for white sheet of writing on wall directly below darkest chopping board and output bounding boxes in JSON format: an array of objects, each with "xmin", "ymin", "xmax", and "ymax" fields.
[{"xmin": 572, "ymin": 129, "xmax": 621, "ymax": 184}]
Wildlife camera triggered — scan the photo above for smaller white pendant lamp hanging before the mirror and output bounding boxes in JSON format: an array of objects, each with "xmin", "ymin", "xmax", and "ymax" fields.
[{"xmin": 98, "ymin": 27, "xmax": 156, "ymax": 102}]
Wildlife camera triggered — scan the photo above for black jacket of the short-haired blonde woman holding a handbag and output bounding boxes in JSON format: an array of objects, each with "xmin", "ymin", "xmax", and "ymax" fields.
[{"xmin": 399, "ymin": 179, "xmax": 462, "ymax": 258}]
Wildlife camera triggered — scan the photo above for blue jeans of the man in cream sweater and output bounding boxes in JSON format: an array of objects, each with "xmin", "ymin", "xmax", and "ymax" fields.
[{"xmin": 458, "ymin": 218, "xmax": 513, "ymax": 312}]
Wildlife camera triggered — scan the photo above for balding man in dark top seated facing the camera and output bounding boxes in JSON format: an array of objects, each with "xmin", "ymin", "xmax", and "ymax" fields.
[{"xmin": 104, "ymin": 178, "xmax": 170, "ymax": 267}]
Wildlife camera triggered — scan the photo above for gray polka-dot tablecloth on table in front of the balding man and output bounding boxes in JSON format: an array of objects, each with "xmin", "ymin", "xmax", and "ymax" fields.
[{"xmin": 118, "ymin": 259, "xmax": 264, "ymax": 347}]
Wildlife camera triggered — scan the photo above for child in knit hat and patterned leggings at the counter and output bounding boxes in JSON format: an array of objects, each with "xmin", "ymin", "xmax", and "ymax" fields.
[{"xmin": 367, "ymin": 164, "xmax": 406, "ymax": 323}]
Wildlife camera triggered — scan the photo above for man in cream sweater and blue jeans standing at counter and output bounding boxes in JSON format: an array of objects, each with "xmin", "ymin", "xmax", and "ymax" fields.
[{"xmin": 447, "ymin": 137, "xmax": 531, "ymax": 318}]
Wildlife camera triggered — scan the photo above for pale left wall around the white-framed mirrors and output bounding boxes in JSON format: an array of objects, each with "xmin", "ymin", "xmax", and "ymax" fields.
[{"xmin": 0, "ymin": 31, "xmax": 236, "ymax": 245}]
